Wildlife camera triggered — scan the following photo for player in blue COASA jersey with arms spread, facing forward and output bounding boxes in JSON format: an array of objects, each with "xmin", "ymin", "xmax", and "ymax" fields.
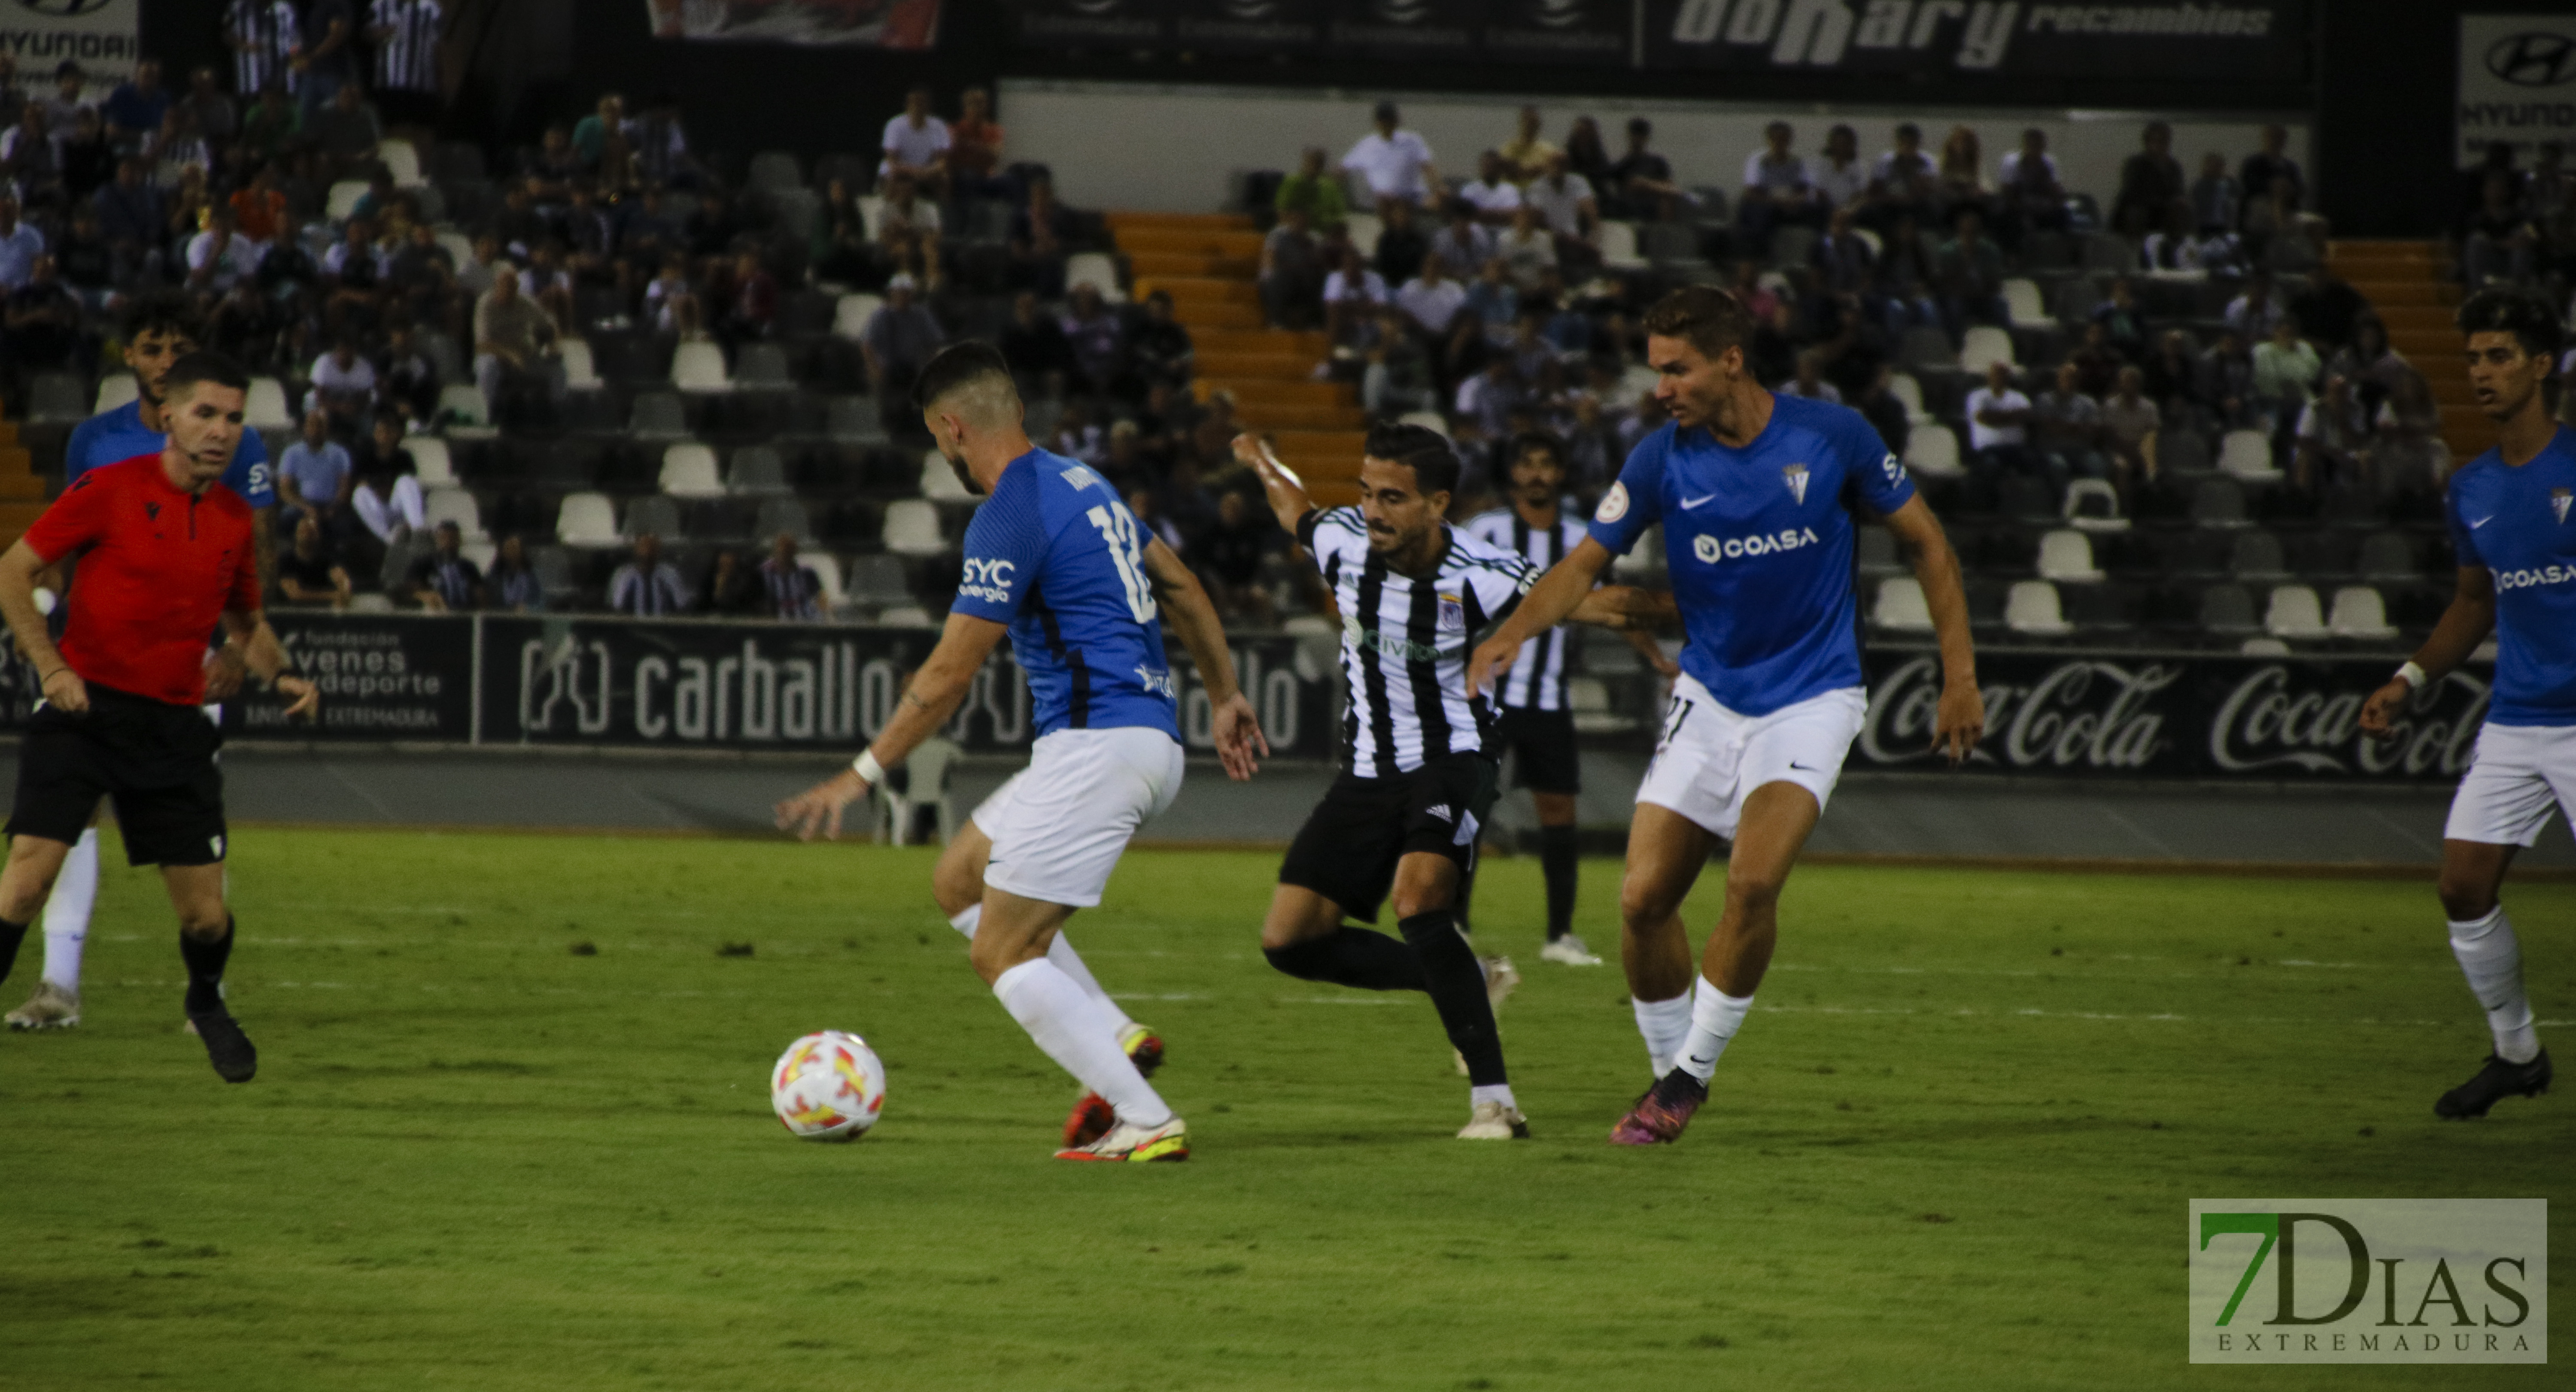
[{"xmin": 1468, "ymin": 286, "xmax": 1986, "ymax": 1144}]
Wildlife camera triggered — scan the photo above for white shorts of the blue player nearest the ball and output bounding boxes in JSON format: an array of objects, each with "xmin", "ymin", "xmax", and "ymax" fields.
[{"xmin": 974, "ymin": 727, "xmax": 1185, "ymax": 907}]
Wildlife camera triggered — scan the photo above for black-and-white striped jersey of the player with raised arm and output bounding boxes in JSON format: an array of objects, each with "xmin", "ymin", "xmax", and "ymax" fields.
[{"xmin": 1296, "ymin": 508, "xmax": 1538, "ymax": 779}]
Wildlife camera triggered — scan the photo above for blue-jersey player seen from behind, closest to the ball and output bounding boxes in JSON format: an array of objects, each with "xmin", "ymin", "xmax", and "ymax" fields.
[{"xmin": 778, "ymin": 343, "xmax": 1270, "ymax": 1160}]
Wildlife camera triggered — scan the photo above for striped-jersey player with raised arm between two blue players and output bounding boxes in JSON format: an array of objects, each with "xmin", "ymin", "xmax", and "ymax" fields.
[{"xmin": 1234, "ymin": 425, "xmax": 1656, "ymax": 1139}]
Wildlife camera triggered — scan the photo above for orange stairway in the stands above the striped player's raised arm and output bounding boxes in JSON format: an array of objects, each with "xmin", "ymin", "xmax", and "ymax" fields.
[{"xmin": 1108, "ymin": 211, "xmax": 1365, "ymax": 505}]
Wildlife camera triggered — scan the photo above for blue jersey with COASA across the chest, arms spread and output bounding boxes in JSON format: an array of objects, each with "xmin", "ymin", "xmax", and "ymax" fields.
[{"xmin": 1592, "ymin": 397, "xmax": 1914, "ymax": 717}]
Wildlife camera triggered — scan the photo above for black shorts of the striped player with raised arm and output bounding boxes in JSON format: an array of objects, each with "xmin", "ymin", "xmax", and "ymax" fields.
[{"xmin": 1280, "ymin": 753, "xmax": 1494, "ymax": 923}]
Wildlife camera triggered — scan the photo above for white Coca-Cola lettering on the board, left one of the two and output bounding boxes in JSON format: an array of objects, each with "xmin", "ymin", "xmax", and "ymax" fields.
[{"xmin": 1860, "ymin": 655, "xmax": 2182, "ymax": 771}]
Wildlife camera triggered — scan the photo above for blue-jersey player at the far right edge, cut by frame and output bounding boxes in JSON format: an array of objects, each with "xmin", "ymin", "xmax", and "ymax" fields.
[{"xmin": 2362, "ymin": 291, "xmax": 2576, "ymax": 1116}]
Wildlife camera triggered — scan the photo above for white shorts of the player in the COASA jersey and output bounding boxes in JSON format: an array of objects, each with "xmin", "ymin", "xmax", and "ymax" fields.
[{"xmin": 1636, "ymin": 673, "xmax": 1870, "ymax": 838}]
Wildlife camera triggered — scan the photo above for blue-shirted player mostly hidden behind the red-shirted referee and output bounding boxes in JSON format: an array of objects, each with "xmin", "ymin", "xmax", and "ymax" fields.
[{"xmin": 5, "ymin": 291, "xmax": 276, "ymax": 1028}]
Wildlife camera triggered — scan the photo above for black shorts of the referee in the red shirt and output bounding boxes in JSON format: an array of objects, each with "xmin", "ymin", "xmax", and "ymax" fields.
[{"xmin": 8, "ymin": 685, "xmax": 224, "ymax": 866}]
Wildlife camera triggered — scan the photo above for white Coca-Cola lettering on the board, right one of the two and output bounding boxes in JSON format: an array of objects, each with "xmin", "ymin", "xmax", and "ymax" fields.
[{"xmin": 2210, "ymin": 662, "xmax": 2488, "ymax": 773}]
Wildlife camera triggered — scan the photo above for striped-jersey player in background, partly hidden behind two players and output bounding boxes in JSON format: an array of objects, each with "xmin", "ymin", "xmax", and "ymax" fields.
[{"xmin": 1458, "ymin": 436, "xmax": 1682, "ymax": 967}]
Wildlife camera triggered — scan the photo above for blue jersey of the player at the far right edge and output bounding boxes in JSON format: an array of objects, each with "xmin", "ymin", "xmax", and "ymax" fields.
[{"xmin": 2450, "ymin": 425, "xmax": 2576, "ymax": 725}]
